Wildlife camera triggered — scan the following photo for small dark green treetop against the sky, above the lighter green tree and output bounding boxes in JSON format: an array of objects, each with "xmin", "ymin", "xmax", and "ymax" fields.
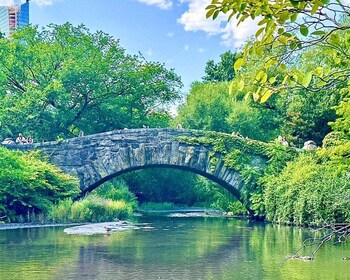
[{"xmin": 202, "ymin": 51, "xmax": 237, "ymax": 82}]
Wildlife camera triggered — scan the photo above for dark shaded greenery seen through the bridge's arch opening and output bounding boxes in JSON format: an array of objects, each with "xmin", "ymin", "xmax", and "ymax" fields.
[{"xmin": 122, "ymin": 168, "xmax": 241, "ymax": 211}]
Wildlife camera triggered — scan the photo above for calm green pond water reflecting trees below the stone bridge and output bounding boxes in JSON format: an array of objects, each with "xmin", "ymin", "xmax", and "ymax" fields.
[{"xmin": 0, "ymin": 217, "xmax": 350, "ymax": 280}]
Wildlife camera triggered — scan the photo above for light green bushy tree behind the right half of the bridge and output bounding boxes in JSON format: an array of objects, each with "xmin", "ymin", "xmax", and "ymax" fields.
[{"xmin": 176, "ymin": 82, "xmax": 278, "ymax": 141}]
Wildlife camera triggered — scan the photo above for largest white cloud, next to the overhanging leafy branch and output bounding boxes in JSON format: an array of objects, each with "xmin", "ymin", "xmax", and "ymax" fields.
[{"xmin": 178, "ymin": 0, "xmax": 258, "ymax": 47}]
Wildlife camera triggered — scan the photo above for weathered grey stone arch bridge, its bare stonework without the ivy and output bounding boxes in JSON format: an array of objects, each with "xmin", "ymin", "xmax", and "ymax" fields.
[{"xmin": 4, "ymin": 129, "xmax": 264, "ymax": 202}]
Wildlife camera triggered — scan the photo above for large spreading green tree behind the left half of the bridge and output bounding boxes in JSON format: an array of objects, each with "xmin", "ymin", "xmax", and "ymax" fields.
[{"xmin": 0, "ymin": 23, "xmax": 182, "ymax": 140}]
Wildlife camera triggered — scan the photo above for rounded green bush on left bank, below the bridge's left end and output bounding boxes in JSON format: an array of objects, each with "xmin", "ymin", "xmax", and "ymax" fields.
[{"xmin": 0, "ymin": 147, "xmax": 80, "ymax": 221}]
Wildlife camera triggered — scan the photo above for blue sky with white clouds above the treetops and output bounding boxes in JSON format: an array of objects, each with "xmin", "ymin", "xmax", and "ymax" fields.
[{"xmin": 0, "ymin": 0, "xmax": 255, "ymax": 92}]
